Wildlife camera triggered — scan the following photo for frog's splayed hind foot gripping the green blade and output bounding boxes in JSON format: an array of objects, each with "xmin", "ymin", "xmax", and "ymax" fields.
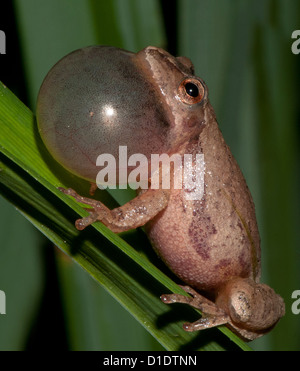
[{"xmin": 161, "ymin": 286, "xmax": 230, "ymax": 332}]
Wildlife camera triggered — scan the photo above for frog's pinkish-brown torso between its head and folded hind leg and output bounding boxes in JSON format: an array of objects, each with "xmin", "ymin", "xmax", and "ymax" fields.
[{"xmin": 146, "ymin": 105, "xmax": 260, "ymax": 291}]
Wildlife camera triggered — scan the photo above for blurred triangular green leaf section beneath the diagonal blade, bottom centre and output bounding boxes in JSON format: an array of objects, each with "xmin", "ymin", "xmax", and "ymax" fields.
[{"xmin": 56, "ymin": 252, "xmax": 163, "ymax": 351}]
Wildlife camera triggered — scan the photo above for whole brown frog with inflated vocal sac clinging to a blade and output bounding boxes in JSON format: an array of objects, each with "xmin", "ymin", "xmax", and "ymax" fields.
[{"xmin": 37, "ymin": 46, "xmax": 285, "ymax": 340}]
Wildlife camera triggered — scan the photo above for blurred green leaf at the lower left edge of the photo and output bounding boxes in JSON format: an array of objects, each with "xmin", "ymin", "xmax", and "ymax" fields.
[{"xmin": 0, "ymin": 196, "xmax": 44, "ymax": 351}]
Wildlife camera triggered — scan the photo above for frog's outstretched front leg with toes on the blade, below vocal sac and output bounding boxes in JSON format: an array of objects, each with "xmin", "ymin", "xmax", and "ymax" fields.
[{"xmin": 59, "ymin": 187, "xmax": 170, "ymax": 233}]
